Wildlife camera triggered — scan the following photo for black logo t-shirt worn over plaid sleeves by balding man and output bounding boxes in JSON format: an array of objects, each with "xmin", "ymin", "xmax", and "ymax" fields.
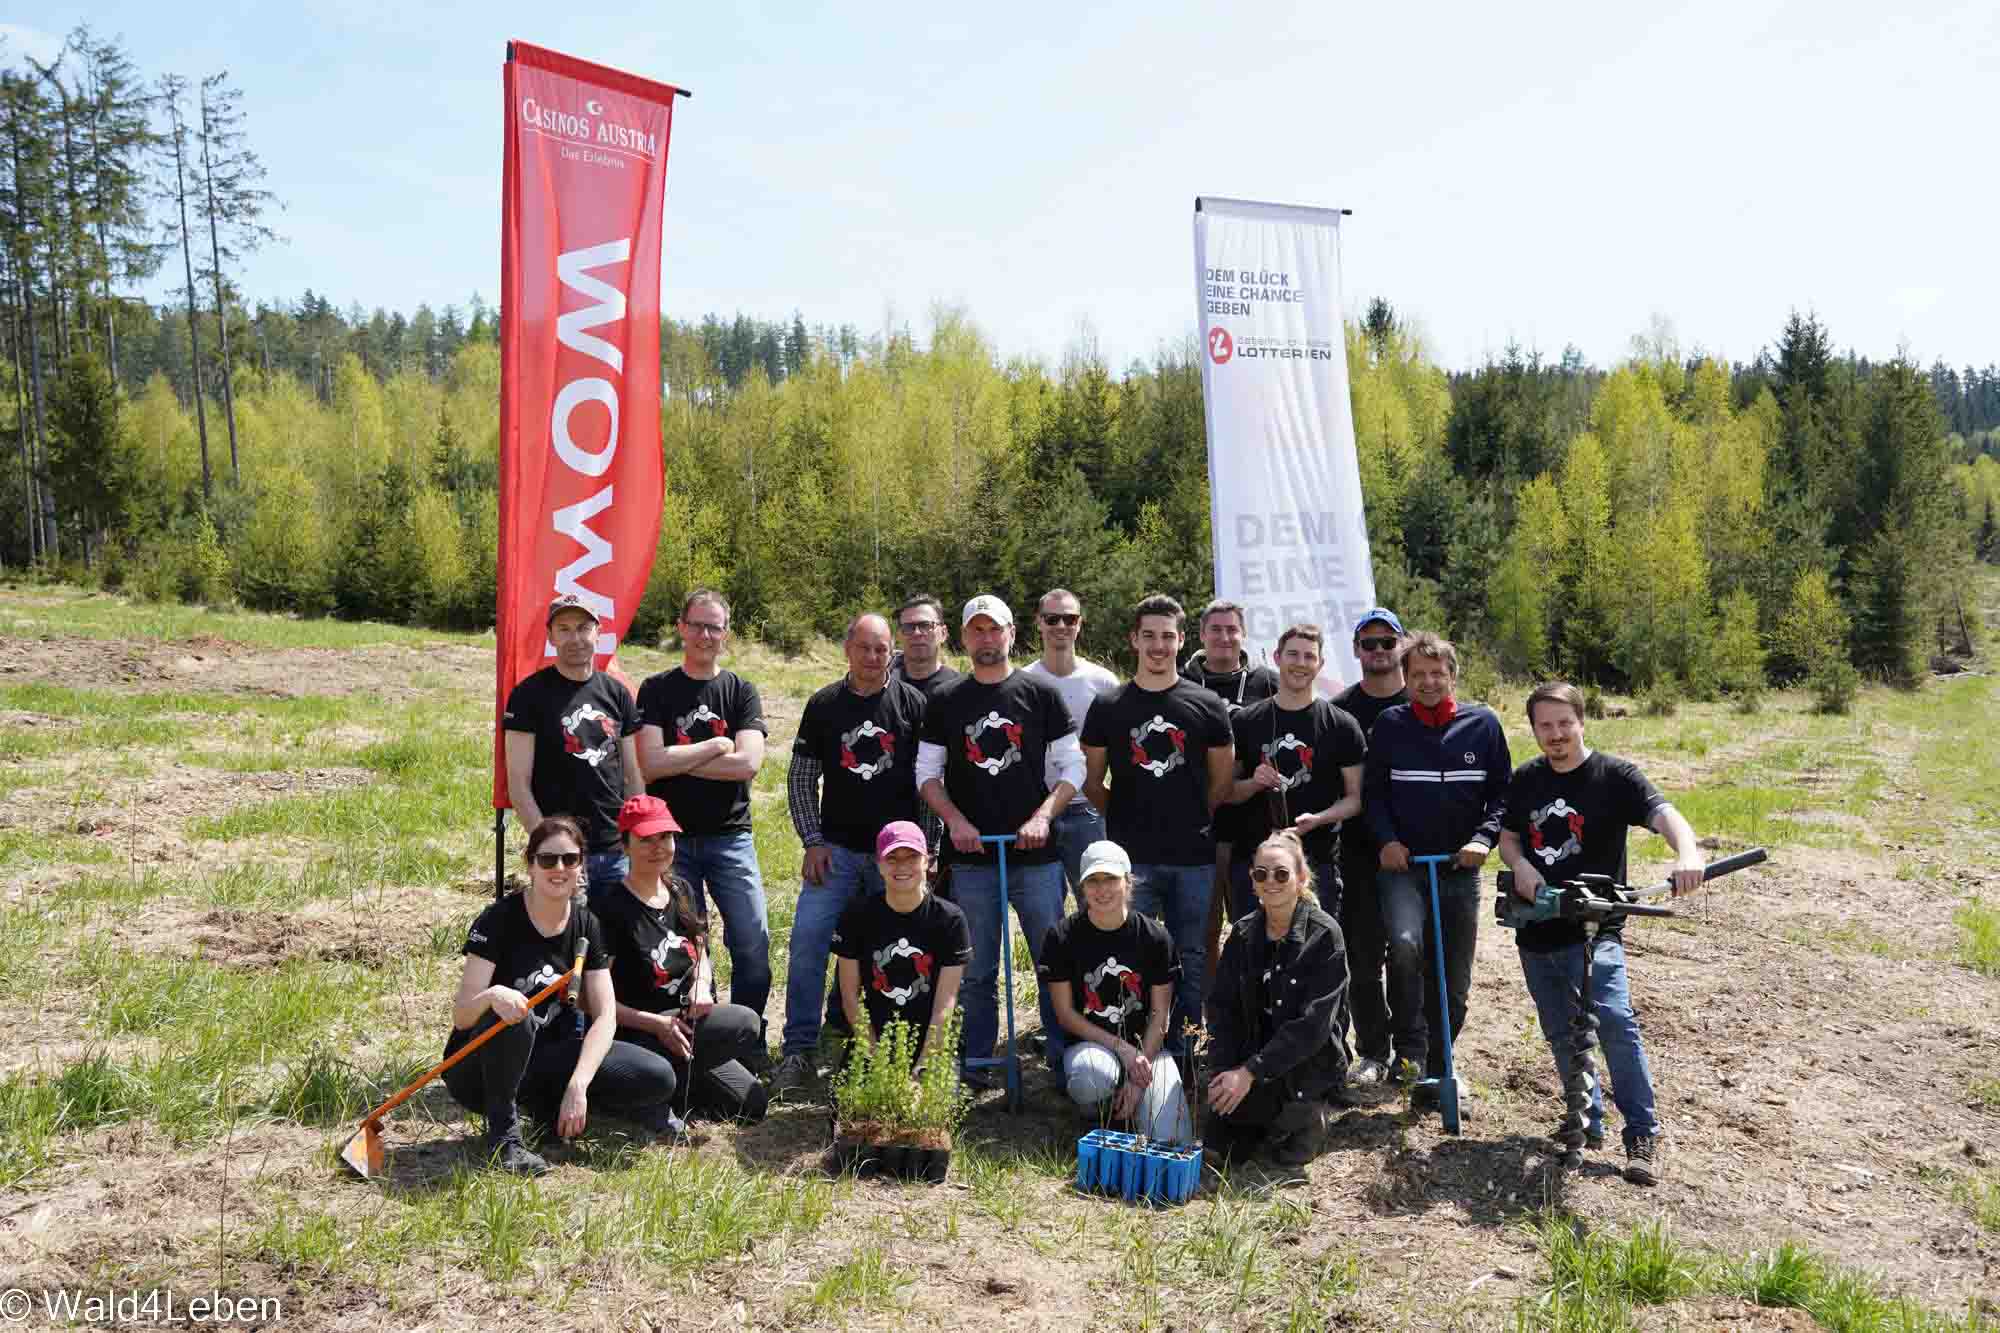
[{"xmin": 792, "ymin": 679, "xmax": 924, "ymax": 855}]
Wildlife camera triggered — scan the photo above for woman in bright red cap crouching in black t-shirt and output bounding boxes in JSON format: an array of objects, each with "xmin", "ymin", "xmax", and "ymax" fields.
[{"xmin": 590, "ymin": 797, "xmax": 768, "ymax": 1129}]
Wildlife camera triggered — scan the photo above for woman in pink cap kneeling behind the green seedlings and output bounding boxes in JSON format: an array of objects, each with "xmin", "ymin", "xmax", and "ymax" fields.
[{"xmin": 834, "ymin": 819, "xmax": 972, "ymax": 1059}]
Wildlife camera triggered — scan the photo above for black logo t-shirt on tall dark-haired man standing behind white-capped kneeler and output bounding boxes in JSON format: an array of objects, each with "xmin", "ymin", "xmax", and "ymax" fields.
[{"xmin": 1084, "ymin": 677, "xmax": 1230, "ymax": 865}]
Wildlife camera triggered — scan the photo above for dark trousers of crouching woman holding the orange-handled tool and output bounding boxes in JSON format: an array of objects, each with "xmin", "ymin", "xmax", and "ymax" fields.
[{"xmin": 444, "ymin": 1009, "xmax": 674, "ymax": 1139}]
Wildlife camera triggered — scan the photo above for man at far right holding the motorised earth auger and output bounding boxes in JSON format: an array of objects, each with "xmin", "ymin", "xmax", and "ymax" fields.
[{"xmin": 1500, "ymin": 681, "xmax": 1702, "ymax": 1185}]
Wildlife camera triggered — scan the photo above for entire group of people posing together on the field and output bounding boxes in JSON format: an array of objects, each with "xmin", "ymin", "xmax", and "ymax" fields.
[{"xmin": 448, "ymin": 588, "xmax": 1700, "ymax": 1183}]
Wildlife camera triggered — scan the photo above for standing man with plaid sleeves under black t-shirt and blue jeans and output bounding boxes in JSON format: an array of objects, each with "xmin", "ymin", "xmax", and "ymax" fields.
[{"xmin": 770, "ymin": 614, "xmax": 924, "ymax": 1097}]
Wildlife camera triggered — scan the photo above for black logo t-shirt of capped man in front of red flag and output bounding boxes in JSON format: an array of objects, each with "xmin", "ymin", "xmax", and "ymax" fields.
[{"xmin": 504, "ymin": 667, "xmax": 640, "ymax": 853}]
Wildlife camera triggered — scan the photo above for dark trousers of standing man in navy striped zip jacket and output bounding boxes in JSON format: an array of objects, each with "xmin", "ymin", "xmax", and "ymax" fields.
[{"xmin": 1376, "ymin": 867, "xmax": 1480, "ymax": 1079}]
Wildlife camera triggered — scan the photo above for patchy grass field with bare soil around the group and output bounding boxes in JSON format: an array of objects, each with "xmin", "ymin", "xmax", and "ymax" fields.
[{"xmin": 0, "ymin": 588, "xmax": 2000, "ymax": 1329}]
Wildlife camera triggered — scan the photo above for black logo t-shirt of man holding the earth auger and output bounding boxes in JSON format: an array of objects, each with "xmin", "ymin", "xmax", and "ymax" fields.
[{"xmin": 1504, "ymin": 751, "xmax": 1666, "ymax": 953}]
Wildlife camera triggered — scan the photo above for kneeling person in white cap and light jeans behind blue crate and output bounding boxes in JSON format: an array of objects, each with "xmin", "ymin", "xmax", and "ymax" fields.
[{"xmin": 1036, "ymin": 843, "xmax": 1194, "ymax": 1145}]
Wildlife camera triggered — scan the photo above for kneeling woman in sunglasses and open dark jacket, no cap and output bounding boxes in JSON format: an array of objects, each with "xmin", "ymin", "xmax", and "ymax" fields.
[{"xmin": 1204, "ymin": 829, "xmax": 1348, "ymax": 1167}]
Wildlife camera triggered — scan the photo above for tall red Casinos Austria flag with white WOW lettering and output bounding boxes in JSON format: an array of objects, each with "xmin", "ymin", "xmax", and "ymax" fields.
[{"xmin": 494, "ymin": 42, "xmax": 678, "ymax": 807}]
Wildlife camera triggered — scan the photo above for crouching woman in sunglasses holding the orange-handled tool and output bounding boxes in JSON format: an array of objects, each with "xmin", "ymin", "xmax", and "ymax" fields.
[{"xmin": 444, "ymin": 815, "xmax": 672, "ymax": 1175}]
